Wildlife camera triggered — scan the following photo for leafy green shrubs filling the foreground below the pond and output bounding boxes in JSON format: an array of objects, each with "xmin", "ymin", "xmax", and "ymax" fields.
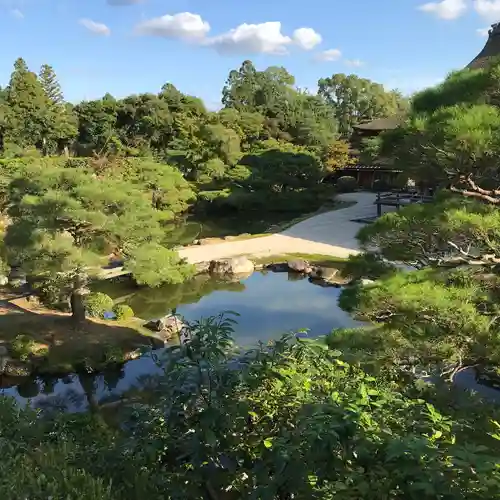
[{"xmin": 0, "ymin": 315, "xmax": 500, "ymax": 500}]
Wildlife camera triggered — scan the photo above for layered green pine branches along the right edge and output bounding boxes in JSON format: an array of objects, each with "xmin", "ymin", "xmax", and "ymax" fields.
[{"xmin": 343, "ymin": 59, "xmax": 500, "ymax": 378}]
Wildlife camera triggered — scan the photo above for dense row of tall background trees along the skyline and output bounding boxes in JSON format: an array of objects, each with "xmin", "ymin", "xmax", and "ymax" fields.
[{"xmin": 0, "ymin": 59, "xmax": 405, "ymax": 217}]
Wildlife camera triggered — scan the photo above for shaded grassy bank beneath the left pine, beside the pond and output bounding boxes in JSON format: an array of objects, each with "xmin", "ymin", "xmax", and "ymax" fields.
[{"xmin": 0, "ymin": 292, "xmax": 158, "ymax": 373}]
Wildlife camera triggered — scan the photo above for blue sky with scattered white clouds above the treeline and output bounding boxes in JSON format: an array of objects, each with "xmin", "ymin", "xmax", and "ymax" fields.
[{"xmin": 0, "ymin": 0, "xmax": 500, "ymax": 108}]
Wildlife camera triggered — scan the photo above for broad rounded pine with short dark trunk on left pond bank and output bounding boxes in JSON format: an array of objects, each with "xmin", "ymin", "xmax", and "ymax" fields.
[{"xmin": 6, "ymin": 165, "xmax": 191, "ymax": 321}]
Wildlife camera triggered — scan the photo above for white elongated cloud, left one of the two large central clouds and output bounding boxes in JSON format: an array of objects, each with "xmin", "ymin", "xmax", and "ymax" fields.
[{"xmin": 135, "ymin": 12, "xmax": 210, "ymax": 41}]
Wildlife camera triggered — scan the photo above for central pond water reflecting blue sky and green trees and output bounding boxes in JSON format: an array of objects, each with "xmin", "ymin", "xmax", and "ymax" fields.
[{"xmin": 99, "ymin": 272, "xmax": 361, "ymax": 346}]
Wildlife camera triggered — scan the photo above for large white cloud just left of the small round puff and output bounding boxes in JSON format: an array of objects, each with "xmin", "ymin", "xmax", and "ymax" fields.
[{"xmin": 206, "ymin": 21, "xmax": 292, "ymax": 54}]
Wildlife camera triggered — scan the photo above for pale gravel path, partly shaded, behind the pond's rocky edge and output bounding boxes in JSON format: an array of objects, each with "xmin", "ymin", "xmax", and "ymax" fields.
[{"xmin": 179, "ymin": 193, "xmax": 376, "ymax": 264}]
